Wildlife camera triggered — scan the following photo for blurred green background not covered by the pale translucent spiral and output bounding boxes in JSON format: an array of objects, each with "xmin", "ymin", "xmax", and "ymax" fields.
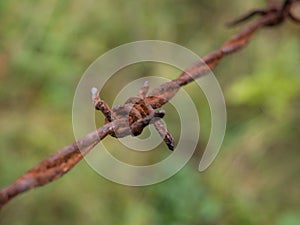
[{"xmin": 0, "ymin": 0, "xmax": 300, "ymax": 225}]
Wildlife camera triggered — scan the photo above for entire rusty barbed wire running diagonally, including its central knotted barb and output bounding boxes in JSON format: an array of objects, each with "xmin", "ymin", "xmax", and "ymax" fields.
[{"xmin": 0, "ymin": 0, "xmax": 300, "ymax": 208}]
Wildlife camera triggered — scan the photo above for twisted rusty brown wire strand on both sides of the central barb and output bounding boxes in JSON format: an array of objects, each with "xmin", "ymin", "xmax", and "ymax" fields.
[{"xmin": 0, "ymin": 0, "xmax": 300, "ymax": 208}]
